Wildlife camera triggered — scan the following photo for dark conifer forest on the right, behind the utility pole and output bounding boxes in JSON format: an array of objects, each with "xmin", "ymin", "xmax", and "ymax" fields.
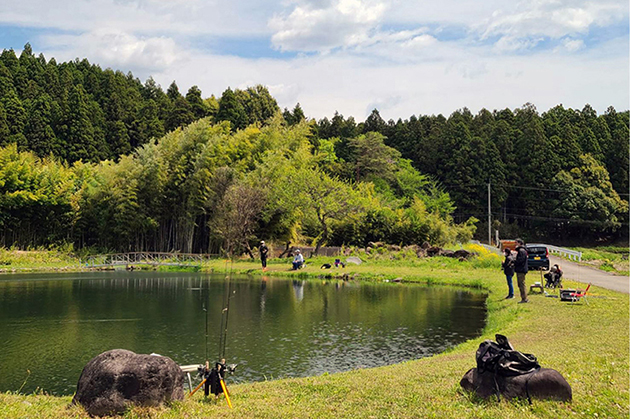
[{"xmin": 316, "ymin": 104, "xmax": 630, "ymax": 242}]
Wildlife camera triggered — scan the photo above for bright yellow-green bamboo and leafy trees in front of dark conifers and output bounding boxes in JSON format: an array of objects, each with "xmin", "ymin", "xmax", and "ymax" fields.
[{"xmin": 0, "ymin": 115, "xmax": 474, "ymax": 253}]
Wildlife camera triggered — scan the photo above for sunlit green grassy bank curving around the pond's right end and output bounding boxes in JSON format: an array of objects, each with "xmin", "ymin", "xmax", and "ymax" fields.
[{"xmin": 0, "ymin": 248, "xmax": 630, "ymax": 418}]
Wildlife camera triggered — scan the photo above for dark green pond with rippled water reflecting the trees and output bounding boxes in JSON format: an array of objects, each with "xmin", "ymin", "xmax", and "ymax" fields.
[{"xmin": 0, "ymin": 271, "xmax": 486, "ymax": 395}]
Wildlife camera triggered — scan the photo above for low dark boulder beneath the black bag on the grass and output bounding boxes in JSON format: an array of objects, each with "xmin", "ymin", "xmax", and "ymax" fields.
[{"xmin": 459, "ymin": 368, "xmax": 572, "ymax": 401}]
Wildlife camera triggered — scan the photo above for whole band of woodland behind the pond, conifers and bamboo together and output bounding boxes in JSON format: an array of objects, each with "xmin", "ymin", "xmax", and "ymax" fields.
[{"xmin": 0, "ymin": 44, "xmax": 629, "ymax": 252}]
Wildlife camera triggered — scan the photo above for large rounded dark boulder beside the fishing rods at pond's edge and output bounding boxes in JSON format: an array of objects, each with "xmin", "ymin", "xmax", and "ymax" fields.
[{"xmin": 72, "ymin": 349, "xmax": 184, "ymax": 416}]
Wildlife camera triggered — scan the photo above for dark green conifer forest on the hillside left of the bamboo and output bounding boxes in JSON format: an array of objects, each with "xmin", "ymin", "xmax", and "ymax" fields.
[{"xmin": 0, "ymin": 44, "xmax": 279, "ymax": 163}]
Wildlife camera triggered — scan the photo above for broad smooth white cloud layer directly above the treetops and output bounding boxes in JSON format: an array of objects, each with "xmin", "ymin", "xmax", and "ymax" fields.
[{"xmin": 141, "ymin": 35, "xmax": 629, "ymax": 121}]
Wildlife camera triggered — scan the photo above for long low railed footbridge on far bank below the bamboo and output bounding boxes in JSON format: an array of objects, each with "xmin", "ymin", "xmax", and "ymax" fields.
[{"xmin": 82, "ymin": 252, "xmax": 218, "ymax": 269}]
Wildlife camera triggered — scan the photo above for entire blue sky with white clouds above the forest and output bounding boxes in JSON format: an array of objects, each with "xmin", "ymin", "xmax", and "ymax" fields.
[{"xmin": 0, "ymin": 0, "xmax": 629, "ymax": 120}]
